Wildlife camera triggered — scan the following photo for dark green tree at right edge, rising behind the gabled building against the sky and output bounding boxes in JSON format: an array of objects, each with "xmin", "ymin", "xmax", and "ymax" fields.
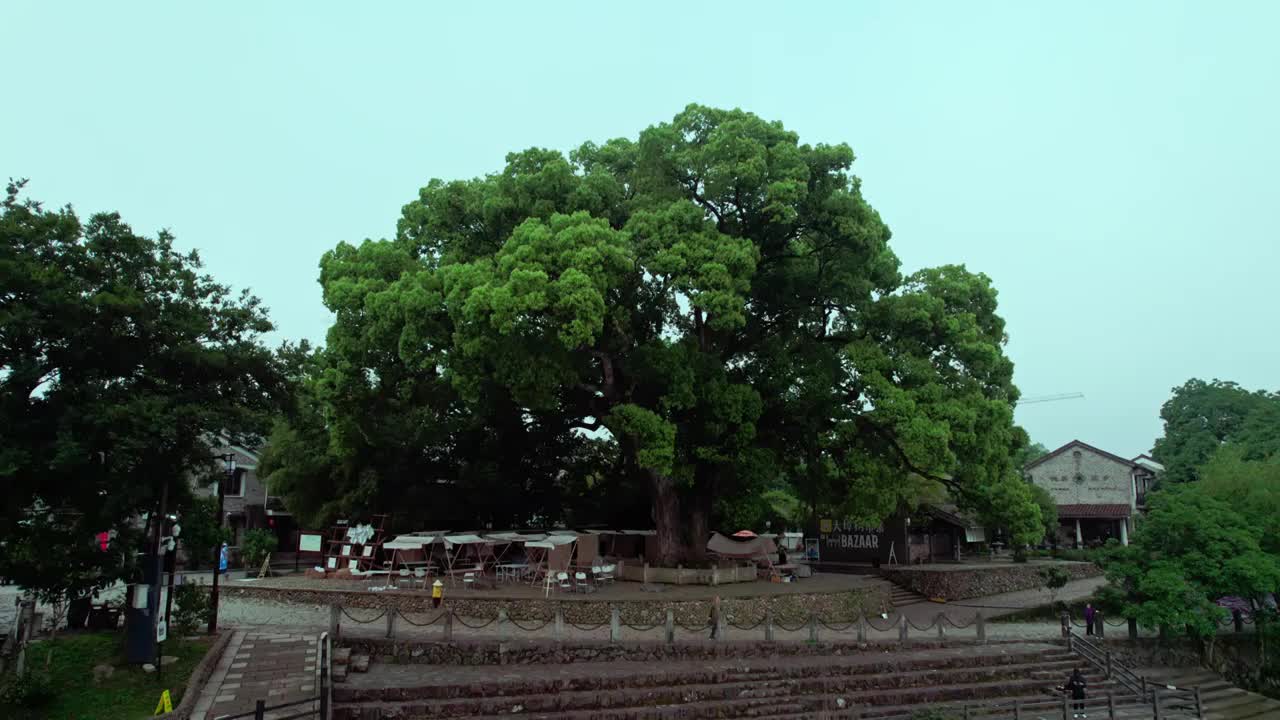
[{"xmin": 1151, "ymin": 379, "xmax": 1280, "ymax": 483}]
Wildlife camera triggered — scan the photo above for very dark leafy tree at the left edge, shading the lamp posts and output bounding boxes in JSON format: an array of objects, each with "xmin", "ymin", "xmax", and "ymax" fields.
[{"xmin": 0, "ymin": 182, "xmax": 284, "ymax": 594}]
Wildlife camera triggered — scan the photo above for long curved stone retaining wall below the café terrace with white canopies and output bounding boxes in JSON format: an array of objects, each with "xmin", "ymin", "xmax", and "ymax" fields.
[{"xmin": 223, "ymin": 584, "xmax": 888, "ymax": 625}]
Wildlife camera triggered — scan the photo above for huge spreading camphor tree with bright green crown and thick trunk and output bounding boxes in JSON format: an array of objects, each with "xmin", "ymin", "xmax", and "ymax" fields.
[{"xmin": 294, "ymin": 105, "xmax": 1039, "ymax": 564}]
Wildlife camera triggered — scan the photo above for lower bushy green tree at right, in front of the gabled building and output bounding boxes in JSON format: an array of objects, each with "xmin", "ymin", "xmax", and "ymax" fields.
[{"xmin": 1106, "ymin": 484, "xmax": 1280, "ymax": 637}]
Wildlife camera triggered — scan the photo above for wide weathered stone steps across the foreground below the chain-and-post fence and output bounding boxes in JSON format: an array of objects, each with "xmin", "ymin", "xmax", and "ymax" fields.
[{"xmin": 334, "ymin": 642, "xmax": 1151, "ymax": 720}]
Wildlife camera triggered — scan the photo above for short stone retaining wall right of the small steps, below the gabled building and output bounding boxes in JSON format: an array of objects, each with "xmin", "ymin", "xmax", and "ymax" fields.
[{"xmin": 881, "ymin": 562, "xmax": 1102, "ymax": 601}]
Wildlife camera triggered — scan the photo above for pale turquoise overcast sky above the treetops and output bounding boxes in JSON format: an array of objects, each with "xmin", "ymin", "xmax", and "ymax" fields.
[{"xmin": 0, "ymin": 0, "xmax": 1280, "ymax": 456}]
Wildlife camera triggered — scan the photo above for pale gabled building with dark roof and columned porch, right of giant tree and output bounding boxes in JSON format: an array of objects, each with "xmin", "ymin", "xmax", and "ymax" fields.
[{"xmin": 1023, "ymin": 439, "xmax": 1164, "ymax": 547}]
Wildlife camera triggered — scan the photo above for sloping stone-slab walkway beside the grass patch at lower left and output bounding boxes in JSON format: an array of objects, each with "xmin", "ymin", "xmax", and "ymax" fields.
[{"xmin": 191, "ymin": 630, "xmax": 319, "ymax": 720}]
